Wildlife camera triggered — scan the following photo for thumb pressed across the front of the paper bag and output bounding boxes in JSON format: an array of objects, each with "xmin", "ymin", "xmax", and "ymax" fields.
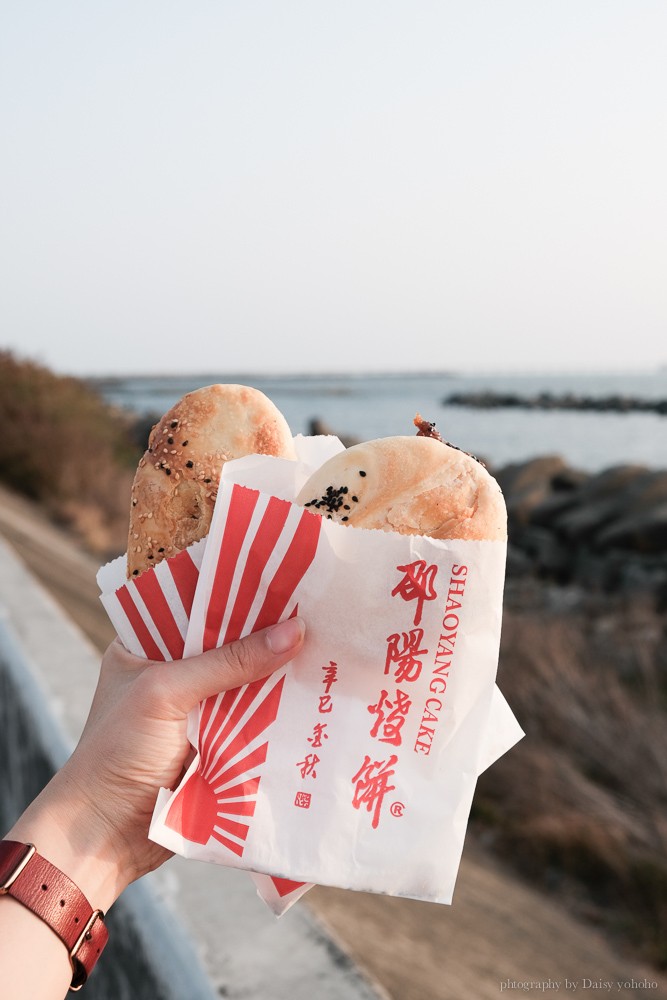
[{"xmin": 159, "ymin": 618, "xmax": 305, "ymax": 712}]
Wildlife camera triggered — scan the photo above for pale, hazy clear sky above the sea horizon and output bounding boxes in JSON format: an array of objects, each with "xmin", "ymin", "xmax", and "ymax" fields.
[{"xmin": 0, "ymin": 0, "xmax": 667, "ymax": 375}]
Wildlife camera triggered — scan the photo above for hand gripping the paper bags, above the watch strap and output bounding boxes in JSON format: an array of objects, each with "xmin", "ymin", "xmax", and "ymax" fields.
[{"xmin": 7, "ymin": 618, "xmax": 304, "ymax": 910}]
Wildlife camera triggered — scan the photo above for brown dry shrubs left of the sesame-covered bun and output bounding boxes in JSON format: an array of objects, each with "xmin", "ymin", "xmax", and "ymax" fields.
[{"xmin": 0, "ymin": 352, "xmax": 139, "ymax": 557}]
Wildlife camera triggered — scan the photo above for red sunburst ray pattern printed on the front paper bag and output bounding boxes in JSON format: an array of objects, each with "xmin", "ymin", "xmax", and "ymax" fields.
[{"xmin": 165, "ymin": 486, "xmax": 322, "ymax": 857}]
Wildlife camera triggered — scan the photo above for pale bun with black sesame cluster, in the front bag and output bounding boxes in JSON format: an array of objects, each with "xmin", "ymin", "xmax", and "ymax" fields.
[{"xmin": 297, "ymin": 437, "xmax": 507, "ymax": 541}]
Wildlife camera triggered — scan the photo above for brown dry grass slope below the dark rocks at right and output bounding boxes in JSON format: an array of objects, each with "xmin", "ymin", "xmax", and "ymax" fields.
[{"xmin": 474, "ymin": 584, "xmax": 667, "ymax": 967}]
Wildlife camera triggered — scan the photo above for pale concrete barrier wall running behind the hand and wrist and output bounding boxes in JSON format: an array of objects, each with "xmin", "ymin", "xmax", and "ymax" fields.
[{"xmin": 0, "ymin": 539, "xmax": 381, "ymax": 1000}]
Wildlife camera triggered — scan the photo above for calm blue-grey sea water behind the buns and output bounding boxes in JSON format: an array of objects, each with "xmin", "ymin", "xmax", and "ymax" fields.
[{"xmin": 94, "ymin": 367, "xmax": 667, "ymax": 472}]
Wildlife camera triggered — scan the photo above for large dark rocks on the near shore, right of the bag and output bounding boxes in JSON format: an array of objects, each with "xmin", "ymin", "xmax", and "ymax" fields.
[{"xmin": 492, "ymin": 456, "xmax": 667, "ymax": 610}]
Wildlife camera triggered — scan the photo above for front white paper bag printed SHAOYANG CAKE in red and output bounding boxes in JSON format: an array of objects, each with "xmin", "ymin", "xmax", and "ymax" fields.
[{"xmin": 141, "ymin": 442, "xmax": 520, "ymax": 902}]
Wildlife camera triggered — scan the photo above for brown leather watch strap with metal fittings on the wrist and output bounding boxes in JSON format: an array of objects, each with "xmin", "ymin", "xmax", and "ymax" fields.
[{"xmin": 0, "ymin": 840, "xmax": 109, "ymax": 991}]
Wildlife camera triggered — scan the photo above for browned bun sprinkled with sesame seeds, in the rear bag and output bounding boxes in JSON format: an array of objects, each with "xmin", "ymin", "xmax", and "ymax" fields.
[{"xmin": 127, "ymin": 385, "xmax": 296, "ymax": 577}]
